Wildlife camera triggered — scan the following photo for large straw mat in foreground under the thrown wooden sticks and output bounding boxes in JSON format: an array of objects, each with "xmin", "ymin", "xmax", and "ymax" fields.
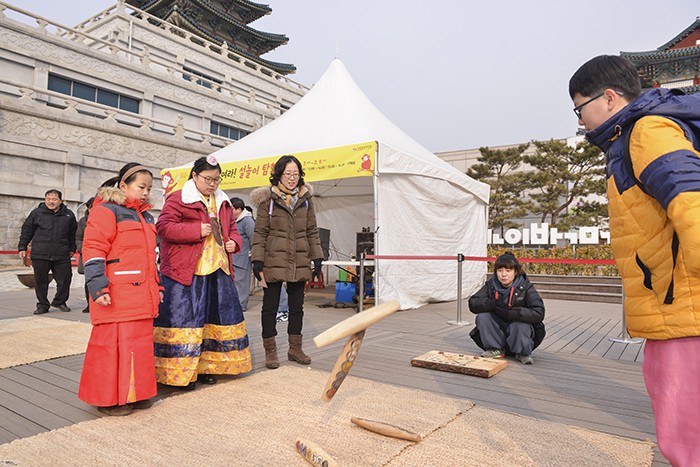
[{"xmin": 0, "ymin": 364, "xmax": 652, "ymax": 467}]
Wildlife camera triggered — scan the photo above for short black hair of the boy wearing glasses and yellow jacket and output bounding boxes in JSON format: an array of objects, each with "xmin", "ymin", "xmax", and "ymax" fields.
[{"xmin": 569, "ymin": 55, "xmax": 642, "ymax": 102}]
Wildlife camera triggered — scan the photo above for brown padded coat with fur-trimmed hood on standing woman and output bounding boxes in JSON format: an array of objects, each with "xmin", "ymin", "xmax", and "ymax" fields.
[{"xmin": 250, "ymin": 185, "xmax": 323, "ymax": 282}]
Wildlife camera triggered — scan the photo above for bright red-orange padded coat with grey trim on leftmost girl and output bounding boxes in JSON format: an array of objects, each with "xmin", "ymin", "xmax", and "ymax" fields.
[{"xmin": 83, "ymin": 188, "xmax": 162, "ymax": 325}]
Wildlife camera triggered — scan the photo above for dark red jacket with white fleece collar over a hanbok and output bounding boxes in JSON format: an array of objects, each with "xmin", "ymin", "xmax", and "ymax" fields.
[{"xmin": 156, "ymin": 180, "xmax": 243, "ymax": 286}]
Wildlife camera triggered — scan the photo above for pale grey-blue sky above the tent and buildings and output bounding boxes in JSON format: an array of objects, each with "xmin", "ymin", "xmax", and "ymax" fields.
[{"xmin": 9, "ymin": 0, "xmax": 700, "ymax": 152}]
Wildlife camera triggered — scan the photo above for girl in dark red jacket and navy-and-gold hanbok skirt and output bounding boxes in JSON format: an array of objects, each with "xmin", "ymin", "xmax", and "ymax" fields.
[{"xmin": 154, "ymin": 155, "xmax": 253, "ymax": 390}]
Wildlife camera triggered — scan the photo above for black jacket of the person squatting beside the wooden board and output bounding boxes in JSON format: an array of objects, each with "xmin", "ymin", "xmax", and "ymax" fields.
[{"xmin": 469, "ymin": 274, "xmax": 546, "ymax": 349}]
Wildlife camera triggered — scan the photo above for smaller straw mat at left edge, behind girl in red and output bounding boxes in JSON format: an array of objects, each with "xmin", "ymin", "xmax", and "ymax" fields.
[{"xmin": 0, "ymin": 316, "xmax": 92, "ymax": 368}]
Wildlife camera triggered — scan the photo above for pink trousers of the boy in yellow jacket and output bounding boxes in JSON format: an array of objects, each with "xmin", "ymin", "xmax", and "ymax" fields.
[{"xmin": 643, "ymin": 337, "xmax": 700, "ymax": 467}]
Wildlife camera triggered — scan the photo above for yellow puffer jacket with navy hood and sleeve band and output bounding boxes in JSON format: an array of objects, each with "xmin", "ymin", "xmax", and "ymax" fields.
[{"xmin": 587, "ymin": 89, "xmax": 700, "ymax": 340}]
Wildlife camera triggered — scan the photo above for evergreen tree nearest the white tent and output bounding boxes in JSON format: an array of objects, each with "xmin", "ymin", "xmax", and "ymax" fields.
[{"xmin": 467, "ymin": 143, "xmax": 529, "ymax": 233}]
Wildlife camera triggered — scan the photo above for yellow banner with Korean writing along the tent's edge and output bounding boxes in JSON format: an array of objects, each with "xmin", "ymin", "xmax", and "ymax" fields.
[{"xmin": 160, "ymin": 141, "xmax": 377, "ymax": 196}]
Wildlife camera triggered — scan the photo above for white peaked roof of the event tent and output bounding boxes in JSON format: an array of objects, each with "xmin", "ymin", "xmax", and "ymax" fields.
[{"xmin": 214, "ymin": 58, "xmax": 489, "ymax": 202}]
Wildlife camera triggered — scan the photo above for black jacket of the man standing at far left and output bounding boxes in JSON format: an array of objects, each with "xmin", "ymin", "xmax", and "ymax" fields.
[{"xmin": 17, "ymin": 203, "xmax": 78, "ymax": 261}]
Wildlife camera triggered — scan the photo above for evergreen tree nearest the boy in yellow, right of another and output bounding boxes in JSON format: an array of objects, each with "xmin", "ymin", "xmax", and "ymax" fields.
[{"xmin": 523, "ymin": 139, "xmax": 607, "ymax": 229}]
